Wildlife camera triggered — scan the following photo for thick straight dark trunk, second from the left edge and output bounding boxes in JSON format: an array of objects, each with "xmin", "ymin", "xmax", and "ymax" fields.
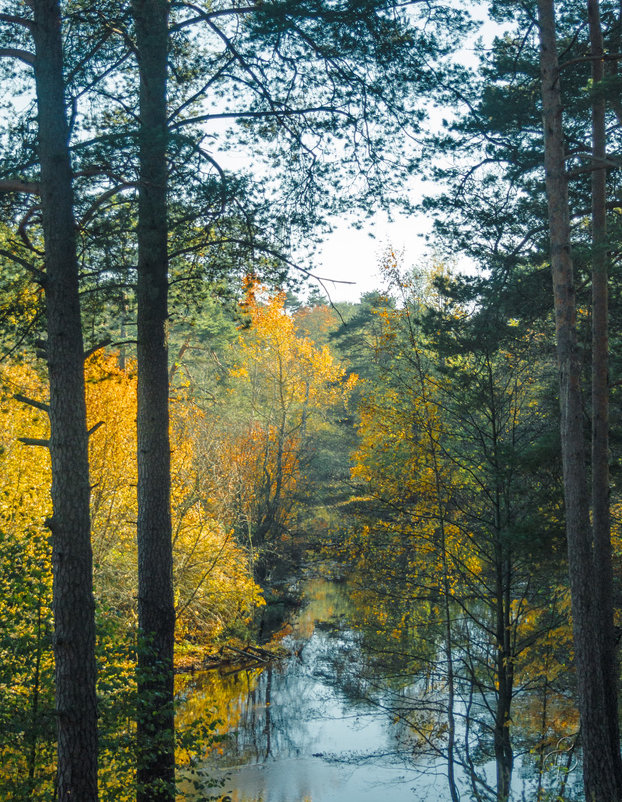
[{"xmin": 132, "ymin": 0, "xmax": 175, "ymax": 802}]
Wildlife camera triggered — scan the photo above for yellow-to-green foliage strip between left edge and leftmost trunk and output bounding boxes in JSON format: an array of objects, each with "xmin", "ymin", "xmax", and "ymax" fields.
[{"xmin": 0, "ymin": 364, "xmax": 54, "ymax": 798}]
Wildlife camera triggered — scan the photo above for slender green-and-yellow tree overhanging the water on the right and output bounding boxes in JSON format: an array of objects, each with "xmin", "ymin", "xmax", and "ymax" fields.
[{"xmin": 344, "ymin": 262, "xmax": 576, "ymax": 788}]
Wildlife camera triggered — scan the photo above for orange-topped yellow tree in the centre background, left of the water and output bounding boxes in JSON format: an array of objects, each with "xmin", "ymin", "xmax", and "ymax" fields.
[{"xmin": 210, "ymin": 279, "xmax": 357, "ymax": 548}]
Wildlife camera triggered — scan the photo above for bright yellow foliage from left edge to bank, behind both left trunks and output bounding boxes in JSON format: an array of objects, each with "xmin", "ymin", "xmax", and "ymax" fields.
[{"xmin": 0, "ymin": 353, "xmax": 261, "ymax": 638}]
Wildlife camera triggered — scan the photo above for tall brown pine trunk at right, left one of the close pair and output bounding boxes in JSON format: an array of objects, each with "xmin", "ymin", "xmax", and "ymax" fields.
[{"xmin": 538, "ymin": 0, "xmax": 622, "ymax": 802}]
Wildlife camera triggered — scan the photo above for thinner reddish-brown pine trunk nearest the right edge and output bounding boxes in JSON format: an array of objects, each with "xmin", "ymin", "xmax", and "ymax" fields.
[{"xmin": 587, "ymin": 0, "xmax": 622, "ymax": 789}]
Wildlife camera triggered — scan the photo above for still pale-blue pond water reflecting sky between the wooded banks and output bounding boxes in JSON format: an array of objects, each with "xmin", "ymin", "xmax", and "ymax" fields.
[{"xmin": 177, "ymin": 580, "xmax": 584, "ymax": 802}]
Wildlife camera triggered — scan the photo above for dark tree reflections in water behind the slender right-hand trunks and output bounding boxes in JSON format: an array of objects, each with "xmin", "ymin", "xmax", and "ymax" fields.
[{"xmin": 333, "ymin": 580, "xmax": 581, "ymax": 802}]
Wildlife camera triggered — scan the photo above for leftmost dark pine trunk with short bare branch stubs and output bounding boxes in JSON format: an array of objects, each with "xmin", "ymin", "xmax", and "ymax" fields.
[{"xmin": 32, "ymin": 0, "xmax": 97, "ymax": 802}]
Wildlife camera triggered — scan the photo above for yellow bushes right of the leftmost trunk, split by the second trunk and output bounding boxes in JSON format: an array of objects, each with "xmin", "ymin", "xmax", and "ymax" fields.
[{"xmin": 86, "ymin": 354, "xmax": 261, "ymax": 640}]
